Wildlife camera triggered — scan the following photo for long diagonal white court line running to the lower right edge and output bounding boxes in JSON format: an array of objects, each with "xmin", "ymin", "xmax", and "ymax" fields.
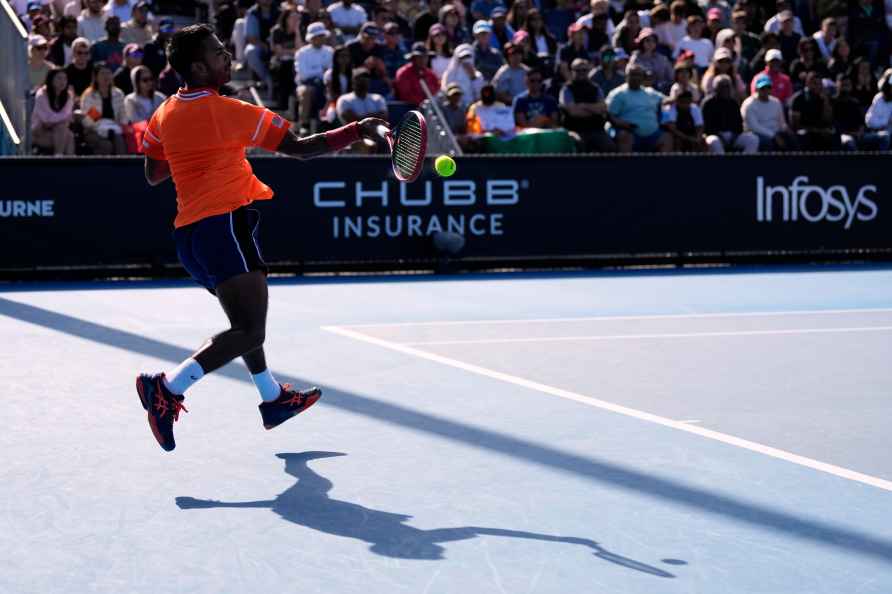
[{"xmin": 322, "ymin": 326, "xmax": 892, "ymax": 491}]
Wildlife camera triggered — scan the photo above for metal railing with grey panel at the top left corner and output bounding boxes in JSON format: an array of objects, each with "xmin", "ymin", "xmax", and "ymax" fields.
[{"xmin": 0, "ymin": 0, "xmax": 31, "ymax": 155}]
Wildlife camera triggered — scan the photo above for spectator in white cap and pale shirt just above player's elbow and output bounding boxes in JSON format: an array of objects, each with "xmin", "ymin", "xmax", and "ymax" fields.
[{"xmin": 294, "ymin": 22, "xmax": 334, "ymax": 136}]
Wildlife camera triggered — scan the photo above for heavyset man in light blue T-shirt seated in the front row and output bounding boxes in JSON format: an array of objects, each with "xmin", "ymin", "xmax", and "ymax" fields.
[{"xmin": 607, "ymin": 64, "xmax": 672, "ymax": 153}]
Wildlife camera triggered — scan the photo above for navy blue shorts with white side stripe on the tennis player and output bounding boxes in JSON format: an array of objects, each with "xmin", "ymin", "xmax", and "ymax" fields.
[{"xmin": 173, "ymin": 206, "xmax": 267, "ymax": 295}]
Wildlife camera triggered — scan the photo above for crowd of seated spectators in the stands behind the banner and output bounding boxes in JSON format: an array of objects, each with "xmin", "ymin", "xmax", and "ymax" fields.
[{"xmin": 13, "ymin": 0, "xmax": 892, "ymax": 154}]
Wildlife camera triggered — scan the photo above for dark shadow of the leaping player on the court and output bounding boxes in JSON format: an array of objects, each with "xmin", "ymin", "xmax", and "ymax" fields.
[{"xmin": 176, "ymin": 452, "xmax": 675, "ymax": 578}]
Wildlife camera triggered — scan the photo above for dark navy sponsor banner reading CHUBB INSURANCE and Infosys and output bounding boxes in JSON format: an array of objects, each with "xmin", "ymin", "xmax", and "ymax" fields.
[{"xmin": 0, "ymin": 155, "xmax": 892, "ymax": 269}]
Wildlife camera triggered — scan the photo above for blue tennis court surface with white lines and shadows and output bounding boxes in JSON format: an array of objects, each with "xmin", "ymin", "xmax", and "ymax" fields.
[{"xmin": 0, "ymin": 267, "xmax": 892, "ymax": 594}]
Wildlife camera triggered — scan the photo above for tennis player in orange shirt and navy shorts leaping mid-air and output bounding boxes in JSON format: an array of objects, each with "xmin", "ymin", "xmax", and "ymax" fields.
[{"xmin": 136, "ymin": 25, "xmax": 387, "ymax": 451}]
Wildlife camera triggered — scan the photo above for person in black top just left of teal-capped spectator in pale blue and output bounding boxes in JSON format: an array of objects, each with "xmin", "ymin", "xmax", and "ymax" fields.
[{"xmin": 700, "ymin": 74, "xmax": 759, "ymax": 155}]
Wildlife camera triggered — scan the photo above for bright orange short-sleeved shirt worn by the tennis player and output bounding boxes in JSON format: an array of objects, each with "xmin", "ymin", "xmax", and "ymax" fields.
[{"xmin": 143, "ymin": 89, "xmax": 290, "ymax": 227}]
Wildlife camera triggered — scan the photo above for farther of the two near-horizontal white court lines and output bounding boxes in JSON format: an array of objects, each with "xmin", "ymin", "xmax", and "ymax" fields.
[{"xmin": 339, "ymin": 307, "xmax": 892, "ymax": 328}]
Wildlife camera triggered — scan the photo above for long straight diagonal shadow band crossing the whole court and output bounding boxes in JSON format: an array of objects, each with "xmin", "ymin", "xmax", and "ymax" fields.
[{"xmin": 0, "ymin": 297, "xmax": 892, "ymax": 565}]
